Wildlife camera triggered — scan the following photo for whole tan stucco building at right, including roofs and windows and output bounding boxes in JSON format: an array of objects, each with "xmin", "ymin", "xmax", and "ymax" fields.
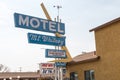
[{"xmin": 67, "ymin": 18, "xmax": 120, "ymax": 80}]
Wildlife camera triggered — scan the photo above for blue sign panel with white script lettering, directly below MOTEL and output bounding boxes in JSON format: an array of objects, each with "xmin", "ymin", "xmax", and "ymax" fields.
[{"xmin": 28, "ymin": 33, "xmax": 66, "ymax": 46}]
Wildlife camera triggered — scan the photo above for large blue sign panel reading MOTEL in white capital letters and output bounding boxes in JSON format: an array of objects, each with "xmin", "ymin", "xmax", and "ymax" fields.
[{"xmin": 14, "ymin": 13, "xmax": 65, "ymax": 34}]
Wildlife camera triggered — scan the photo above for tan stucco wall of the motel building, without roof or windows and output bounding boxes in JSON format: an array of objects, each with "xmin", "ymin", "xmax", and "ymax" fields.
[{"xmin": 68, "ymin": 22, "xmax": 120, "ymax": 80}]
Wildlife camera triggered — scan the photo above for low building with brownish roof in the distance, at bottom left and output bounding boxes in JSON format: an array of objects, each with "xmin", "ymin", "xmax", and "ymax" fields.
[{"xmin": 0, "ymin": 72, "xmax": 40, "ymax": 80}]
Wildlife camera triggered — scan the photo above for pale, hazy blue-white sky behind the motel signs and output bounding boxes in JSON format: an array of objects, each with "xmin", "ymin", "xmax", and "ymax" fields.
[{"xmin": 0, "ymin": 0, "xmax": 120, "ymax": 71}]
